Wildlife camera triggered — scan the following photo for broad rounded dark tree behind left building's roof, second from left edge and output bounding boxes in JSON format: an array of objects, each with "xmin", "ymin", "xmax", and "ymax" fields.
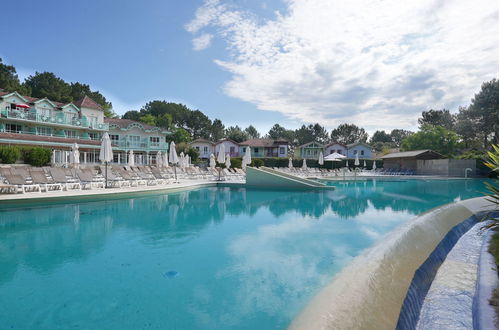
[{"xmin": 23, "ymin": 72, "xmax": 73, "ymax": 103}]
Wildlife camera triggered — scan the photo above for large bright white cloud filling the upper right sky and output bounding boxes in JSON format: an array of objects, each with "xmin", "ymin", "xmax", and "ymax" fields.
[{"xmin": 186, "ymin": 0, "xmax": 499, "ymax": 130}]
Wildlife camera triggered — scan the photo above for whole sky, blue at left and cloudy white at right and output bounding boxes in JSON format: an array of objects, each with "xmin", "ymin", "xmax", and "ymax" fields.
[{"xmin": 0, "ymin": 0, "xmax": 499, "ymax": 132}]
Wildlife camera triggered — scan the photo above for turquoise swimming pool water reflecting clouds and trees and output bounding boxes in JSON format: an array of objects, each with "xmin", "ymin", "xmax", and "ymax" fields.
[{"xmin": 0, "ymin": 179, "xmax": 492, "ymax": 329}]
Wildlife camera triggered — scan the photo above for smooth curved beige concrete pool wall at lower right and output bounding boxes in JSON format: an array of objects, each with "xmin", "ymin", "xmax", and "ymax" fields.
[{"xmin": 290, "ymin": 197, "xmax": 496, "ymax": 329}]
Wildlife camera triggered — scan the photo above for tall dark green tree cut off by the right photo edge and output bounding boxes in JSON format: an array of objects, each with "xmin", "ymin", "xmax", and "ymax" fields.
[{"xmin": 468, "ymin": 79, "xmax": 499, "ymax": 149}]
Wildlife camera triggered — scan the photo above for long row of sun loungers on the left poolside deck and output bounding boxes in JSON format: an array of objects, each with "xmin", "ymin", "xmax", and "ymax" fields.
[{"xmin": 0, "ymin": 165, "xmax": 245, "ymax": 193}]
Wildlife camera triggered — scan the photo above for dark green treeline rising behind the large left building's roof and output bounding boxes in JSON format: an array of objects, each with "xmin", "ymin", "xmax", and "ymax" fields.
[{"xmin": 0, "ymin": 58, "xmax": 116, "ymax": 117}]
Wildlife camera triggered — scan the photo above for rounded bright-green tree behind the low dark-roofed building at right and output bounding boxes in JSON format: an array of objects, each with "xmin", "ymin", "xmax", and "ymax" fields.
[{"xmin": 401, "ymin": 124, "xmax": 460, "ymax": 157}]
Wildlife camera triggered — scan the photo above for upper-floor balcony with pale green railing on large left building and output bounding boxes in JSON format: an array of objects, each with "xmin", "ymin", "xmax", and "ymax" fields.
[{"xmin": 0, "ymin": 108, "xmax": 109, "ymax": 131}]
